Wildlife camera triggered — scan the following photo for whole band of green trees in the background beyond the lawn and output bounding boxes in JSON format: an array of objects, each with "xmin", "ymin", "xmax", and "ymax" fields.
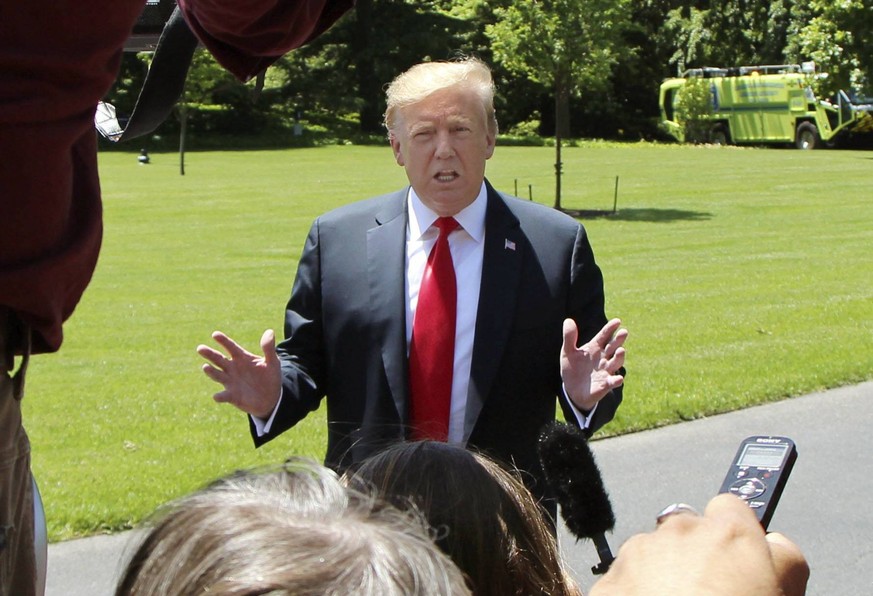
[{"xmin": 108, "ymin": 0, "xmax": 873, "ymax": 148}]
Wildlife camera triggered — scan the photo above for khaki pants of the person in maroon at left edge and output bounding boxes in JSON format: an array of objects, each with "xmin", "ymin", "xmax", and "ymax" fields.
[{"xmin": 0, "ymin": 308, "xmax": 36, "ymax": 596}]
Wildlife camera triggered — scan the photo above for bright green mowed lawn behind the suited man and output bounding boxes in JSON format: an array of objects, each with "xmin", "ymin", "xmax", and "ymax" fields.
[{"xmin": 24, "ymin": 143, "xmax": 873, "ymax": 540}]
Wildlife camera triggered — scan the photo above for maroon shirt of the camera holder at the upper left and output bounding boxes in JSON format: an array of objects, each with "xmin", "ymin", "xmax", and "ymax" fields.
[{"xmin": 0, "ymin": 0, "xmax": 354, "ymax": 353}]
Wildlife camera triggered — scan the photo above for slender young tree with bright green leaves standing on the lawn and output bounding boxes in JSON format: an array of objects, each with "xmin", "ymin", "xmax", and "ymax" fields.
[{"xmin": 485, "ymin": 0, "xmax": 629, "ymax": 209}]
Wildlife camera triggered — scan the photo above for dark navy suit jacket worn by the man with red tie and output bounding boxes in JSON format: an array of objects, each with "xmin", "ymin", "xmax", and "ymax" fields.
[{"xmin": 253, "ymin": 184, "xmax": 621, "ymax": 508}]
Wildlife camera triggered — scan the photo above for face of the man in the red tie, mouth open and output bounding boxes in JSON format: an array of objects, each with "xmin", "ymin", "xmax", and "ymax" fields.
[{"xmin": 391, "ymin": 87, "xmax": 495, "ymax": 216}]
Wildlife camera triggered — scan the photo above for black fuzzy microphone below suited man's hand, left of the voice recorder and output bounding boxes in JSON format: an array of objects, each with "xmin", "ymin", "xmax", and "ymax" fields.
[{"xmin": 538, "ymin": 422, "xmax": 615, "ymax": 575}]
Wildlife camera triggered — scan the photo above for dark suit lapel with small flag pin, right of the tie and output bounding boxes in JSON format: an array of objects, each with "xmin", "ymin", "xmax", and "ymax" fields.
[{"xmin": 464, "ymin": 181, "xmax": 527, "ymax": 443}]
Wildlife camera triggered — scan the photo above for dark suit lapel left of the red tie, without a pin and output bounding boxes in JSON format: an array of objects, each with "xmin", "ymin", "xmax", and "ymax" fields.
[{"xmin": 367, "ymin": 190, "xmax": 408, "ymax": 422}]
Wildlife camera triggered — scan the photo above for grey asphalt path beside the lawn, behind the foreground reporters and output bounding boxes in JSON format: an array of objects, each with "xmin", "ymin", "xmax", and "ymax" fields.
[{"xmin": 46, "ymin": 382, "xmax": 873, "ymax": 596}]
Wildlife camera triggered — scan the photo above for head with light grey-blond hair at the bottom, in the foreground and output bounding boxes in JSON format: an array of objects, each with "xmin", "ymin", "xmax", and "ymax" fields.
[{"xmin": 116, "ymin": 460, "xmax": 469, "ymax": 596}]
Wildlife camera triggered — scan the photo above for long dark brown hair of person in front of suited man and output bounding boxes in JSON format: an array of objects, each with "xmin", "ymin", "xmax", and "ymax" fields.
[{"xmin": 347, "ymin": 441, "xmax": 581, "ymax": 596}]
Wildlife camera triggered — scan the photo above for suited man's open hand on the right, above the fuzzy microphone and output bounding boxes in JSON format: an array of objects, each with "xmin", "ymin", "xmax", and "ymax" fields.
[{"xmin": 561, "ymin": 319, "xmax": 627, "ymax": 411}]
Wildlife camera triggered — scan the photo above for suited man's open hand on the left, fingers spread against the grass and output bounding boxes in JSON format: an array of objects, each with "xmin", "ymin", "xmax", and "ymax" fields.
[{"xmin": 197, "ymin": 329, "xmax": 282, "ymax": 419}]
